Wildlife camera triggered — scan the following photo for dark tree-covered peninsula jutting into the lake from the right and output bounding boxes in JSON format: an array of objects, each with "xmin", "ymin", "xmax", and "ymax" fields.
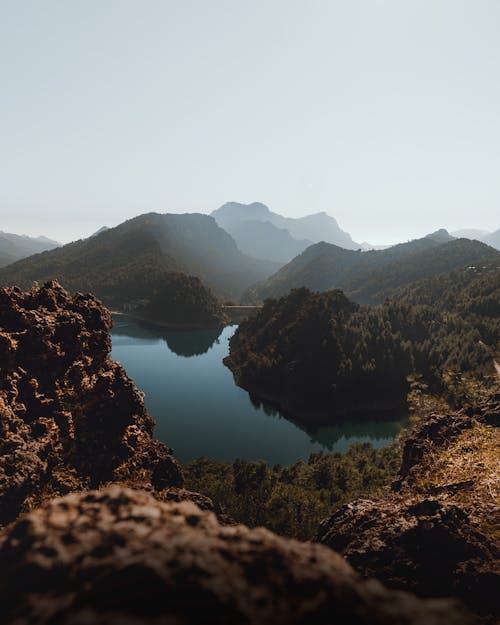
[{"xmin": 225, "ymin": 280, "xmax": 500, "ymax": 423}]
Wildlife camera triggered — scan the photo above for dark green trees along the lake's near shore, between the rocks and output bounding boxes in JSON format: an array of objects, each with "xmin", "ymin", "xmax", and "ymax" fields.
[{"xmin": 184, "ymin": 442, "xmax": 401, "ymax": 540}]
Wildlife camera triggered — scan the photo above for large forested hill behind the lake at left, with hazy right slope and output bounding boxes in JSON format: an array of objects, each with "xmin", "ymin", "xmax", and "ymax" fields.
[{"xmin": 0, "ymin": 213, "xmax": 279, "ymax": 301}]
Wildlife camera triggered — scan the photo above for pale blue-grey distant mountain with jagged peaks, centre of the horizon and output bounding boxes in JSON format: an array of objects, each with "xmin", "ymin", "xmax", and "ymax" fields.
[{"xmin": 212, "ymin": 202, "xmax": 359, "ymax": 262}]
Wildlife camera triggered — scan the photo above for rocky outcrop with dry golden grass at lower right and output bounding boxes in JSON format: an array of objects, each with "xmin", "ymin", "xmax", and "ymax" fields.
[{"xmin": 317, "ymin": 395, "xmax": 500, "ymax": 615}]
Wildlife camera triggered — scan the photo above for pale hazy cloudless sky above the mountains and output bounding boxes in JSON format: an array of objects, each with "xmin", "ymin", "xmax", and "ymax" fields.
[{"xmin": 0, "ymin": 0, "xmax": 500, "ymax": 243}]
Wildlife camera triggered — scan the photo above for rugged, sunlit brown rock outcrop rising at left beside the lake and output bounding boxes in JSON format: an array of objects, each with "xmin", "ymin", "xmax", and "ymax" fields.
[{"xmin": 0, "ymin": 282, "xmax": 182, "ymax": 524}]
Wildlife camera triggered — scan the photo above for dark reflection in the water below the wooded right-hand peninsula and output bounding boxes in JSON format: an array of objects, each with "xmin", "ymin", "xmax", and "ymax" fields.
[{"xmin": 250, "ymin": 396, "xmax": 407, "ymax": 451}]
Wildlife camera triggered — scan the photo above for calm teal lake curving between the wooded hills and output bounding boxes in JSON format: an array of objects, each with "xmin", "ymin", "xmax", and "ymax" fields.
[{"xmin": 111, "ymin": 316, "xmax": 405, "ymax": 465}]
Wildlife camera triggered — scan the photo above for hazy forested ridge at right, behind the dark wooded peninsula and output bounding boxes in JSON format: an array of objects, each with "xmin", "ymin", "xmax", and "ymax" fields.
[{"xmin": 244, "ymin": 237, "xmax": 500, "ymax": 304}]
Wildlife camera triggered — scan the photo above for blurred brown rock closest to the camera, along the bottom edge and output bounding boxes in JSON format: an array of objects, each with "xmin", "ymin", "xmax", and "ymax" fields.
[{"xmin": 0, "ymin": 486, "xmax": 472, "ymax": 625}]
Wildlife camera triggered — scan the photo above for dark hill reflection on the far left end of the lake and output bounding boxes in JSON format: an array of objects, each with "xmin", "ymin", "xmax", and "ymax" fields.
[{"xmin": 112, "ymin": 316, "xmax": 222, "ymax": 358}]
